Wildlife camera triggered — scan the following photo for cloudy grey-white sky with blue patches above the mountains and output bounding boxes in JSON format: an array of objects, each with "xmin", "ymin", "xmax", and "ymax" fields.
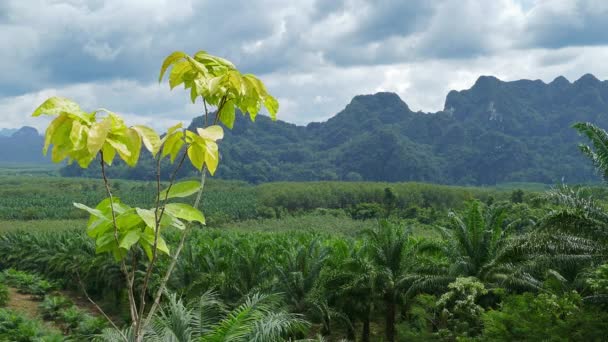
[{"xmin": 0, "ymin": 0, "xmax": 608, "ymax": 130}]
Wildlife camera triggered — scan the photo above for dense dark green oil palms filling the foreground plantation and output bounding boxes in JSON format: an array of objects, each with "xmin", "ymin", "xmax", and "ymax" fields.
[{"xmin": 0, "ymin": 182, "xmax": 608, "ymax": 341}]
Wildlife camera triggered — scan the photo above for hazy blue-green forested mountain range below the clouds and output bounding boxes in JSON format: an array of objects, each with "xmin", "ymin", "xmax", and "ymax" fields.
[{"xmin": 0, "ymin": 74, "xmax": 608, "ymax": 184}]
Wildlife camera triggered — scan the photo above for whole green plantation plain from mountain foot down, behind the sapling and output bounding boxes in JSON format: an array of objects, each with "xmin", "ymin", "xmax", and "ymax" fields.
[{"xmin": 0, "ymin": 175, "xmax": 608, "ymax": 341}]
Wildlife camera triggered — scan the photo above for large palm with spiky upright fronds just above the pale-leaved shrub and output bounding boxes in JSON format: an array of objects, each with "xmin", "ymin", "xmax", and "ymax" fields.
[{"xmin": 444, "ymin": 201, "xmax": 596, "ymax": 290}]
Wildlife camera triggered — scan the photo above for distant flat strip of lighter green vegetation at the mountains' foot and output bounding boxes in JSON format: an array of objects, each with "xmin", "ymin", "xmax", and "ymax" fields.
[{"xmin": 0, "ymin": 175, "xmax": 536, "ymax": 220}]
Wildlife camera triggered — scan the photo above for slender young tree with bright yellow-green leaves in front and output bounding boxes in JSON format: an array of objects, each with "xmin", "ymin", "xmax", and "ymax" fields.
[{"xmin": 32, "ymin": 51, "xmax": 279, "ymax": 341}]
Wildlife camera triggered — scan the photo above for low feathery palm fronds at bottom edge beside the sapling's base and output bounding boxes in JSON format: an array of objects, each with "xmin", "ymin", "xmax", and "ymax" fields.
[{"xmin": 97, "ymin": 292, "xmax": 308, "ymax": 342}]
